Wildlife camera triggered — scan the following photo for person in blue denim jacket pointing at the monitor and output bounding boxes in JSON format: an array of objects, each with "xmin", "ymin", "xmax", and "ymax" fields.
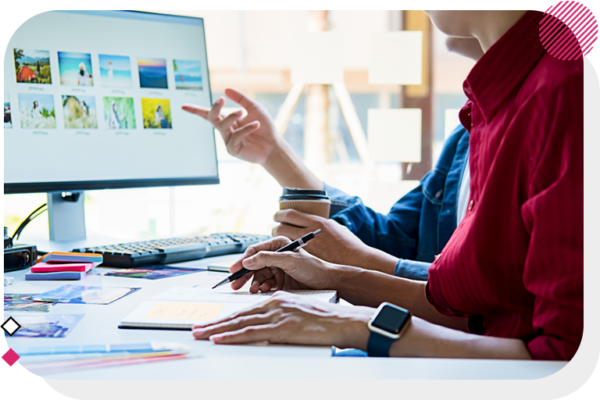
[{"xmin": 183, "ymin": 38, "xmax": 483, "ymax": 284}]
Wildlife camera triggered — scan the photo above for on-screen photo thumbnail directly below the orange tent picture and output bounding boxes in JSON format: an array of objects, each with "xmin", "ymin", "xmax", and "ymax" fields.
[{"xmin": 19, "ymin": 93, "xmax": 56, "ymax": 129}]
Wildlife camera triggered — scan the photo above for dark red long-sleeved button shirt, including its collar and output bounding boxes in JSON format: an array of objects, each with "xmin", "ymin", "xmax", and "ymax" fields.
[{"xmin": 426, "ymin": 11, "xmax": 583, "ymax": 360}]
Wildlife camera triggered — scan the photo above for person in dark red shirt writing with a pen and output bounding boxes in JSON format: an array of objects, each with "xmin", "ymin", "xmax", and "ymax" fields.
[{"xmin": 193, "ymin": 10, "xmax": 583, "ymax": 360}]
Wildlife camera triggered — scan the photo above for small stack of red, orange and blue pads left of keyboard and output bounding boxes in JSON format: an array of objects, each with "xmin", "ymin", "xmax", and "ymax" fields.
[{"xmin": 25, "ymin": 252, "xmax": 102, "ymax": 281}]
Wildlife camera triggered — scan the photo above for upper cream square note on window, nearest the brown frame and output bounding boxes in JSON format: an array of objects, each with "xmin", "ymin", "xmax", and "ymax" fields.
[{"xmin": 369, "ymin": 31, "xmax": 423, "ymax": 85}]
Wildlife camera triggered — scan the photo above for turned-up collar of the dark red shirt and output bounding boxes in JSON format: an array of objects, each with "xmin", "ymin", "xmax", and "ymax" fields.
[{"xmin": 463, "ymin": 10, "xmax": 544, "ymax": 122}]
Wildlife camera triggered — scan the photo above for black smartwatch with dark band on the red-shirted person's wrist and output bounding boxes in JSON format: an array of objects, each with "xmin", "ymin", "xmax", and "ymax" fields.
[{"xmin": 367, "ymin": 303, "xmax": 410, "ymax": 357}]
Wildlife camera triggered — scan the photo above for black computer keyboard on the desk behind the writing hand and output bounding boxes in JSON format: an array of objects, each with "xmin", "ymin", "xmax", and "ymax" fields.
[{"xmin": 72, "ymin": 233, "xmax": 270, "ymax": 268}]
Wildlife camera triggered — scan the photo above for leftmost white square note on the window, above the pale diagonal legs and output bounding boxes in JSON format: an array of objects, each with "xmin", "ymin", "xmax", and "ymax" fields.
[{"xmin": 291, "ymin": 32, "xmax": 344, "ymax": 85}]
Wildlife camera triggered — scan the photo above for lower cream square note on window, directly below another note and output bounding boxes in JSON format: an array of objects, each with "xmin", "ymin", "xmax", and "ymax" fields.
[{"xmin": 367, "ymin": 108, "xmax": 421, "ymax": 162}]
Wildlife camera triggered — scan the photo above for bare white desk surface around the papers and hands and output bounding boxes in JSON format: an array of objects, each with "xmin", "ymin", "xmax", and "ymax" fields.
[{"xmin": 4, "ymin": 256, "xmax": 566, "ymax": 380}]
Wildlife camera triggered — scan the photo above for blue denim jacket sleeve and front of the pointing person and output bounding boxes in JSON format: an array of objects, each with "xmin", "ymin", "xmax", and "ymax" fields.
[{"xmin": 325, "ymin": 125, "xmax": 469, "ymax": 280}]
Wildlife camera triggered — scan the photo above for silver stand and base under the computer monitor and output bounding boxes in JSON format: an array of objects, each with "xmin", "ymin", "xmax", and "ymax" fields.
[{"xmin": 15, "ymin": 192, "xmax": 123, "ymax": 253}]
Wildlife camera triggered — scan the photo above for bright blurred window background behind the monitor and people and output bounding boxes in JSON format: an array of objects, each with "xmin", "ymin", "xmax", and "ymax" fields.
[{"xmin": 3, "ymin": 10, "xmax": 474, "ymax": 241}]
